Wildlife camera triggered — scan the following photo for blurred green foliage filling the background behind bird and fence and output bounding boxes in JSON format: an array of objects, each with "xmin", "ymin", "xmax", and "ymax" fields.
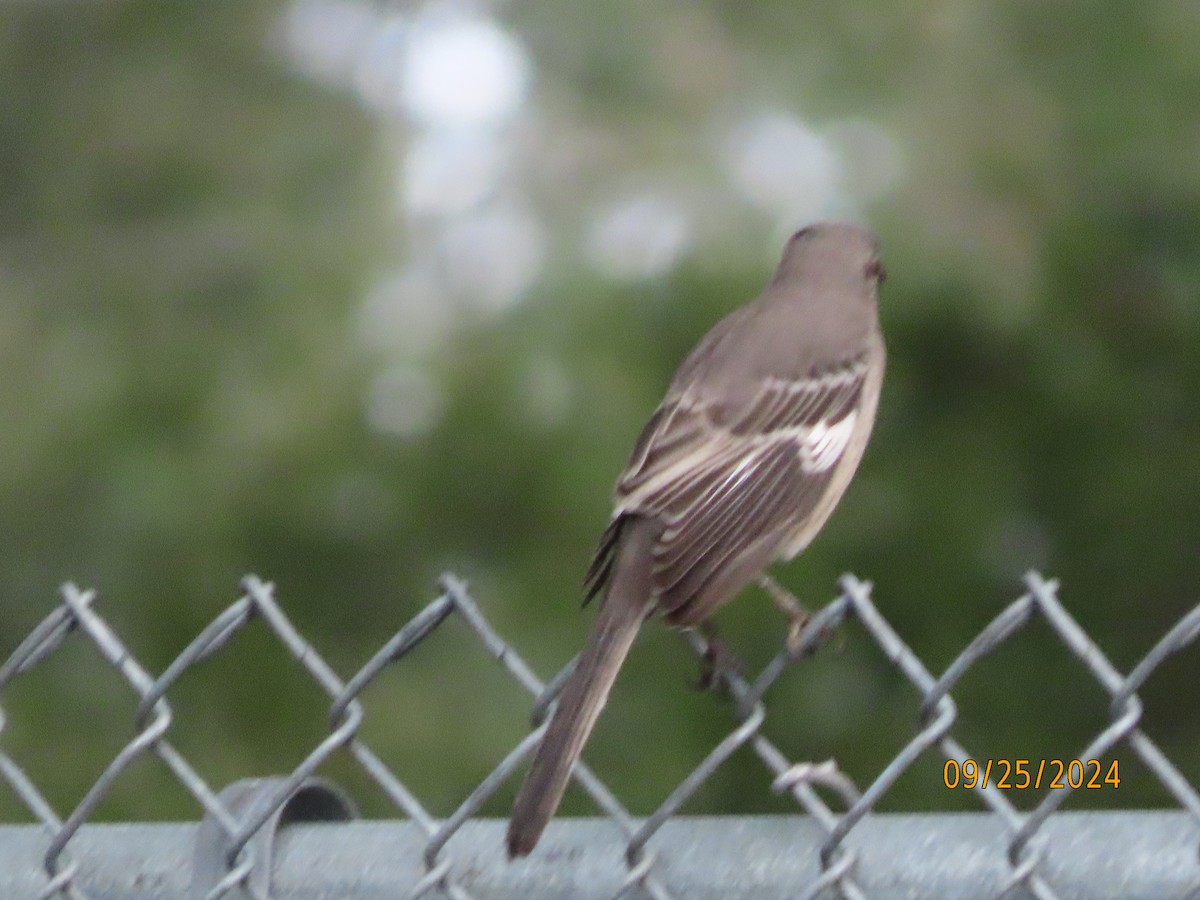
[{"xmin": 0, "ymin": 0, "xmax": 1200, "ymax": 820}]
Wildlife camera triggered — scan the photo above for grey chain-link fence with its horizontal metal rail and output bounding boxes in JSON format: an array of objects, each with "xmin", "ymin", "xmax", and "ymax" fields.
[{"xmin": 0, "ymin": 574, "xmax": 1200, "ymax": 900}]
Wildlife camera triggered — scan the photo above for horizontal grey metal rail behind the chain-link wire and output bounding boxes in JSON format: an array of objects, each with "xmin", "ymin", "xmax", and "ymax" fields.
[{"xmin": 0, "ymin": 810, "xmax": 1200, "ymax": 900}]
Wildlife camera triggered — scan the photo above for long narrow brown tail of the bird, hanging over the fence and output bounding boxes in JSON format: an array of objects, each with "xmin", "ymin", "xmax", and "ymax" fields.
[{"xmin": 508, "ymin": 517, "xmax": 658, "ymax": 859}]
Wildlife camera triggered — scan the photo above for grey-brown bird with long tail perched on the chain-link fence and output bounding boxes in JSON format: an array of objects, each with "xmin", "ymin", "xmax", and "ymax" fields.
[{"xmin": 506, "ymin": 222, "xmax": 886, "ymax": 859}]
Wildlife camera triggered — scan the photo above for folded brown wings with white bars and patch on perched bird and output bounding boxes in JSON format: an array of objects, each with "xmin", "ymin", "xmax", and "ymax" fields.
[{"xmin": 589, "ymin": 359, "xmax": 866, "ymax": 612}]
